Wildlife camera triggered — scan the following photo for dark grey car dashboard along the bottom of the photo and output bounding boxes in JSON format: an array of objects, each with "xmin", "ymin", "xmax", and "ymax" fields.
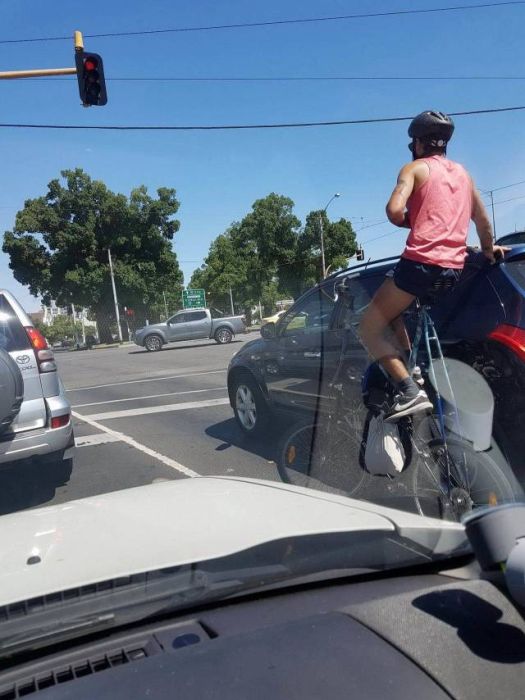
[{"xmin": 0, "ymin": 564, "xmax": 525, "ymax": 700}]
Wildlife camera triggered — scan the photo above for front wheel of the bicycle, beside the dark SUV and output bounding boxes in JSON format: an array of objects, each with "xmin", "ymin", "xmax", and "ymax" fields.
[{"xmin": 278, "ymin": 423, "xmax": 367, "ymax": 496}]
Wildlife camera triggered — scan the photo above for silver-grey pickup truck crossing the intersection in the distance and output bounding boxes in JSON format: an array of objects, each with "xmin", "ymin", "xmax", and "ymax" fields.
[{"xmin": 133, "ymin": 309, "xmax": 246, "ymax": 352}]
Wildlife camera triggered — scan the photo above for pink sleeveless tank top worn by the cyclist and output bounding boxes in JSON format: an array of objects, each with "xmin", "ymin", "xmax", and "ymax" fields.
[{"xmin": 402, "ymin": 156, "xmax": 472, "ymax": 270}]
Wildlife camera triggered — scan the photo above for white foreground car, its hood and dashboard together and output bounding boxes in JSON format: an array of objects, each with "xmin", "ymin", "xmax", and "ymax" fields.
[{"xmin": 0, "ymin": 477, "xmax": 525, "ymax": 700}]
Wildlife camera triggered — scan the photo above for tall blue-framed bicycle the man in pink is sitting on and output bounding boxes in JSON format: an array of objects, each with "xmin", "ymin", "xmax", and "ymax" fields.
[{"xmin": 278, "ymin": 282, "xmax": 516, "ymax": 520}]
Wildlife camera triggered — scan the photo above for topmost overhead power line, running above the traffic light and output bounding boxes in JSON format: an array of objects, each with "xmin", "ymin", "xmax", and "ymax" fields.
[{"xmin": 0, "ymin": 0, "xmax": 525, "ymax": 44}]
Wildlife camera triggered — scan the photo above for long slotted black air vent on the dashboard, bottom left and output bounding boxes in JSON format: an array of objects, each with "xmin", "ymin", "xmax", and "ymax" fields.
[{"xmin": 0, "ymin": 647, "xmax": 148, "ymax": 700}]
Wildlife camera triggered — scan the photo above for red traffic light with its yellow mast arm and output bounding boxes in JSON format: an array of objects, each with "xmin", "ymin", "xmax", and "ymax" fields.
[{"xmin": 0, "ymin": 31, "xmax": 108, "ymax": 107}]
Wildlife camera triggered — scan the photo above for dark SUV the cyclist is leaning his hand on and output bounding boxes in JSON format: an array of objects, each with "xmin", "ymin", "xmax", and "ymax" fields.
[{"xmin": 228, "ymin": 245, "xmax": 525, "ymax": 479}]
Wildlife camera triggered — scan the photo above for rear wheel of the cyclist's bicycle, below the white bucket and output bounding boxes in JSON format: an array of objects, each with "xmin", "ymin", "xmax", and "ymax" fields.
[{"xmin": 413, "ymin": 417, "xmax": 516, "ymax": 521}]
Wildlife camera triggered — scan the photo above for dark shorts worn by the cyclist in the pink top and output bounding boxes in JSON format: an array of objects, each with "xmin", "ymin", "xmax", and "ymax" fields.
[{"xmin": 393, "ymin": 258, "xmax": 461, "ymax": 299}]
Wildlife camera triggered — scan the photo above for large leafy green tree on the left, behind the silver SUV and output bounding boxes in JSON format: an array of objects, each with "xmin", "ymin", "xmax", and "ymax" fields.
[{"xmin": 3, "ymin": 168, "xmax": 182, "ymax": 342}]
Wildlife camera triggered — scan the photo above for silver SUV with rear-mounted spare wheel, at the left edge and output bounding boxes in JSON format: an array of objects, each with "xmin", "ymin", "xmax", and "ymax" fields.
[{"xmin": 0, "ymin": 290, "xmax": 75, "ymax": 481}]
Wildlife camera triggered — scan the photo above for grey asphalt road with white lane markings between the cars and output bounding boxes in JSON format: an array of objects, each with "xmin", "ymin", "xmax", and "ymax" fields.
[{"xmin": 0, "ymin": 335, "xmax": 422, "ymax": 514}]
